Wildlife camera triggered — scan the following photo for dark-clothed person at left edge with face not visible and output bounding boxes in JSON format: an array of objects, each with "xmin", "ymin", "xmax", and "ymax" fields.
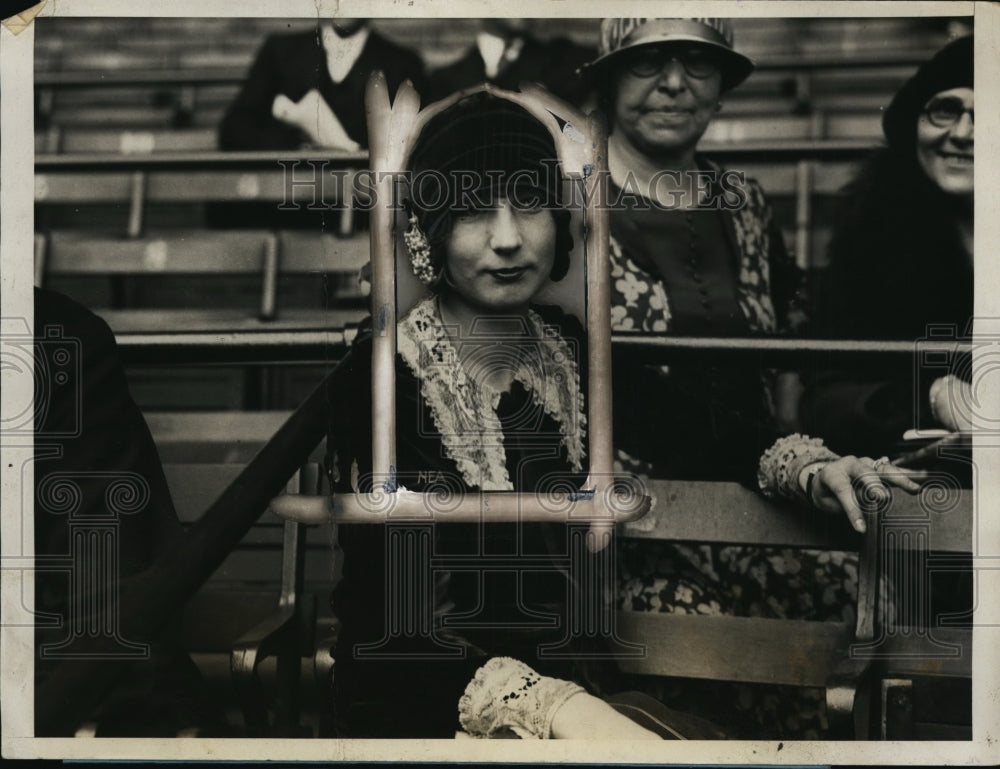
[{"xmin": 34, "ymin": 288, "xmax": 228, "ymax": 737}]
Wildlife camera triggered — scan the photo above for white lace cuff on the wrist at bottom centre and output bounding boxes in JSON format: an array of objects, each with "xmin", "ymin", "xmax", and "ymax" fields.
[{"xmin": 458, "ymin": 657, "xmax": 583, "ymax": 740}]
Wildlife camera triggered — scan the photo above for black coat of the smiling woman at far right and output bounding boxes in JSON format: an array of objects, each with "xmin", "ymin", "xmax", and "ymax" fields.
[{"xmin": 802, "ymin": 150, "xmax": 973, "ymax": 457}]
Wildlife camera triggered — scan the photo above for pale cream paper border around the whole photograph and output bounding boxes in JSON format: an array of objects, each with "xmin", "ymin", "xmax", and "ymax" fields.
[{"xmin": 0, "ymin": 0, "xmax": 1000, "ymax": 765}]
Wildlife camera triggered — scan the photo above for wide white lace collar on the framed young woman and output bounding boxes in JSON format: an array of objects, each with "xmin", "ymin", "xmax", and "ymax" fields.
[{"xmin": 396, "ymin": 299, "xmax": 586, "ymax": 491}]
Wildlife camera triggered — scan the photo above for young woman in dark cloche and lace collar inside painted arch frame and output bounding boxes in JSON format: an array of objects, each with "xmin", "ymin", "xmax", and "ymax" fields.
[{"xmin": 328, "ymin": 92, "xmax": 736, "ymax": 739}]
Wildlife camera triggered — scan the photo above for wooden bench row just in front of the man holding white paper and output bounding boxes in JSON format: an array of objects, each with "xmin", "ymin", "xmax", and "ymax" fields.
[{"xmin": 35, "ymin": 146, "xmax": 875, "ymax": 267}]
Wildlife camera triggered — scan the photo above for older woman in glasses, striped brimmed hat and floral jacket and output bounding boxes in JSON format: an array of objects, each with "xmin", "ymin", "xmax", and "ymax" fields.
[{"xmin": 582, "ymin": 19, "xmax": 805, "ymax": 478}]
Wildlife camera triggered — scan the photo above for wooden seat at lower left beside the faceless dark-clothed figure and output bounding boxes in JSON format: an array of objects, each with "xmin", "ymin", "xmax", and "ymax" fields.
[{"xmin": 147, "ymin": 412, "xmax": 337, "ymax": 737}]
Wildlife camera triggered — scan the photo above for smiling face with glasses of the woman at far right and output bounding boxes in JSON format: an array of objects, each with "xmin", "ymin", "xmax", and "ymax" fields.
[{"xmin": 917, "ymin": 88, "xmax": 974, "ymax": 195}]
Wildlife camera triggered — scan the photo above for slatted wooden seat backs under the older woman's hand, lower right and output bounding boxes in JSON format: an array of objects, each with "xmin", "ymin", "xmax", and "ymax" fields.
[{"xmin": 618, "ymin": 481, "xmax": 972, "ymax": 686}]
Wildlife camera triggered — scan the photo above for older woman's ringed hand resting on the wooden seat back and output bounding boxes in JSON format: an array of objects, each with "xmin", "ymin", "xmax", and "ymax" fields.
[{"xmin": 802, "ymin": 456, "xmax": 927, "ymax": 532}]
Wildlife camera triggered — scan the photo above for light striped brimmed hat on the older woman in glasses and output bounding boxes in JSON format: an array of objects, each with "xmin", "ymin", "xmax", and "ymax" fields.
[{"xmin": 580, "ymin": 18, "xmax": 754, "ymax": 91}]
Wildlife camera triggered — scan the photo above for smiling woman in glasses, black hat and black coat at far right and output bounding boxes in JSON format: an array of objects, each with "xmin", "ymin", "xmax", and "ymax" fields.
[{"xmin": 803, "ymin": 36, "xmax": 974, "ymax": 455}]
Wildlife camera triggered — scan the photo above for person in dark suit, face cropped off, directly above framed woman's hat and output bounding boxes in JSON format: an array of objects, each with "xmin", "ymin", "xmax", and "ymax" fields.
[{"xmin": 421, "ymin": 19, "xmax": 594, "ymax": 105}]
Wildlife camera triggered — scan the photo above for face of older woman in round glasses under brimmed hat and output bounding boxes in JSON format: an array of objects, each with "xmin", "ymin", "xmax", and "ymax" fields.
[{"xmin": 612, "ymin": 44, "xmax": 722, "ymax": 156}]
